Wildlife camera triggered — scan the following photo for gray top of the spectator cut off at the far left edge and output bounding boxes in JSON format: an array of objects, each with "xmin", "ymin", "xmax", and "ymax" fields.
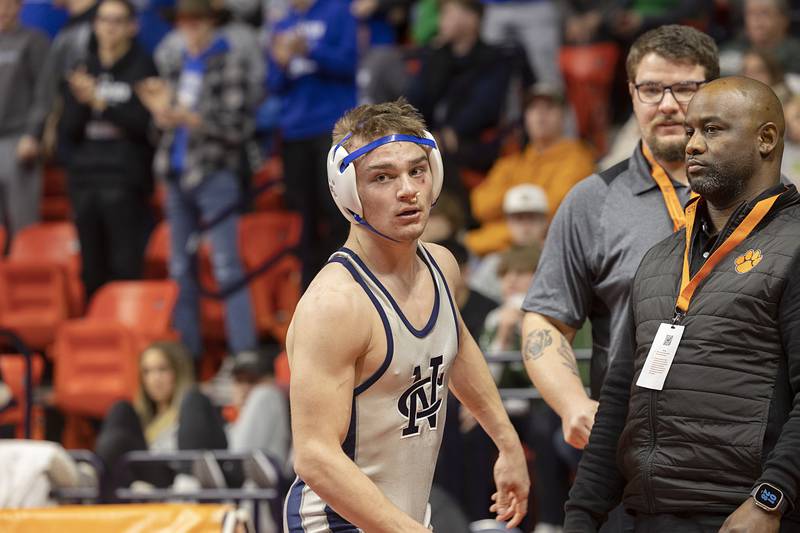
[{"xmin": 0, "ymin": 25, "xmax": 50, "ymax": 137}]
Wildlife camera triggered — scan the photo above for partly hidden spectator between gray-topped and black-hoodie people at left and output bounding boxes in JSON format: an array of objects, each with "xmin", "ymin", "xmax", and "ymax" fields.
[{"xmin": 18, "ymin": 0, "xmax": 97, "ymax": 156}]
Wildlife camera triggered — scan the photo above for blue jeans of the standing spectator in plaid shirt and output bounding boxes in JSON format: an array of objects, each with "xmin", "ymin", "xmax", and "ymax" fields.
[{"xmin": 166, "ymin": 171, "xmax": 257, "ymax": 358}]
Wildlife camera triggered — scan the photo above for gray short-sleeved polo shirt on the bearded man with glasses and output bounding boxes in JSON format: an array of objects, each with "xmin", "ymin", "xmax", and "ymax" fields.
[{"xmin": 522, "ymin": 145, "xmax": 690, "ymax": 398}]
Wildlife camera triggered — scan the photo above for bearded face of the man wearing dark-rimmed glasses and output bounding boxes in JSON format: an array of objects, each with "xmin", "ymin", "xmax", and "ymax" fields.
[{"xmin": 628, "ymin": 52, "xmax": 706, "ymax": 162}]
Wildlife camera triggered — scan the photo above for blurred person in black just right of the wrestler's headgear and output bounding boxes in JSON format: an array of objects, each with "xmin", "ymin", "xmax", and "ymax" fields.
[{"xmin": 408, "ymin": 0, "xmax": 511, "ymax": 208}]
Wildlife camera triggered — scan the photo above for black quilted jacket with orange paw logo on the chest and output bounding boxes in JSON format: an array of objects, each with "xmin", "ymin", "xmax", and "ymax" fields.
[{"xmin": 565, "ymin": 186, "xmax": 800, "ymax": 531}]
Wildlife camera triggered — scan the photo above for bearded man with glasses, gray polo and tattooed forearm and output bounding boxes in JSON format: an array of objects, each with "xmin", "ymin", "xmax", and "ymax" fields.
[{"xmin": 522, "ymin": 25, "xmax": 719, "ymax": 528}]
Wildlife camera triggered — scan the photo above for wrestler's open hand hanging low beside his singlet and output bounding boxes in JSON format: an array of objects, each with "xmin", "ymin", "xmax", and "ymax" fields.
[{"xmin": 489, "ymin": 444, "xmax": 531, "ymax": 528}]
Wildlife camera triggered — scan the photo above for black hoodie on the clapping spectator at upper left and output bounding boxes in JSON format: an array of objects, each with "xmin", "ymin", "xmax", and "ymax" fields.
[{"xmin": 59, "ymin": 39, "xmax": 157, "ymax": 191}]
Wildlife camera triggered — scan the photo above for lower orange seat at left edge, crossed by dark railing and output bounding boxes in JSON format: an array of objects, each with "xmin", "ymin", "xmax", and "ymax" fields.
[{"xmin": 0, "ymin": 354, "xmax": 44, "ymax": 439}]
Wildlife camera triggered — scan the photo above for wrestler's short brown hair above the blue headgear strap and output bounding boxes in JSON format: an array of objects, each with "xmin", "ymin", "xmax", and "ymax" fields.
[{"xmin": 333, "ymin": 97, "xmax": 432, "ymax": 152}]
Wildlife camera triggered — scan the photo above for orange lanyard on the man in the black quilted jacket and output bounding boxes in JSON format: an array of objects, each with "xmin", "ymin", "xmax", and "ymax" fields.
[{"xmin": 672, "ymin": 193, "xmax": 781, "ymax": 324}]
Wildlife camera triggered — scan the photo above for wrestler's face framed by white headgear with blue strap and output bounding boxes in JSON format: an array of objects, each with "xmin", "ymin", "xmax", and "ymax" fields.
[{"xmin": 355, "ymin": 142, "xmax": 433, "ymax": 242}]
